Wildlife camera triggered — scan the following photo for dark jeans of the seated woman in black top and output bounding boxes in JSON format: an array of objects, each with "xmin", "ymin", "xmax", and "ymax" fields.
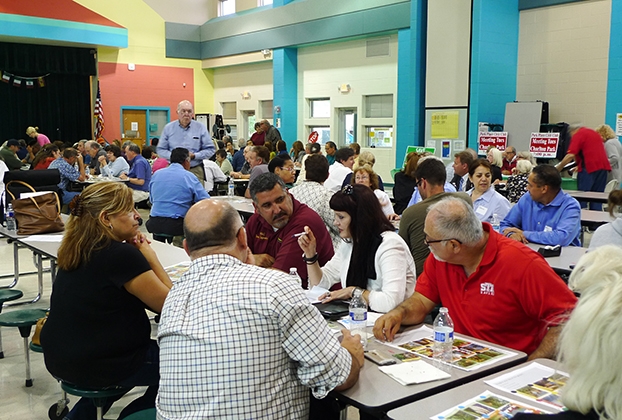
[{"xmin": 65, "ymin": 340, "xmax": 160, "ymax": 420}]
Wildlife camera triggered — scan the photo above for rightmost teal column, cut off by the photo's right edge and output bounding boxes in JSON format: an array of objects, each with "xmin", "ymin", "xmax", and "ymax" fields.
[{"xmin": 605, "ymin": 1, "xmax": 622, "ymax": 131}]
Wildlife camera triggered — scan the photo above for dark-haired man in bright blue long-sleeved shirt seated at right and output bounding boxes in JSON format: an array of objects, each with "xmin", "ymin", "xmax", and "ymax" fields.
[{"xmin": 501, "ymin": 165, "xmax": 581, "ymax": 246}]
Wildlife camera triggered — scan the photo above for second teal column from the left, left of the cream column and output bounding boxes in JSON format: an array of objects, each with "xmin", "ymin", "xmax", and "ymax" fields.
[{"xmin": 395, "ymin": 0, "xmax": 428, "ymax": 171}]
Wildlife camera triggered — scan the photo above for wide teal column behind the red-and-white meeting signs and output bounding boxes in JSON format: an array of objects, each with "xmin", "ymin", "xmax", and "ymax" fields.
[{"xmin": 467, "ymin": 0, "xmax": 519, "ymax": 149}]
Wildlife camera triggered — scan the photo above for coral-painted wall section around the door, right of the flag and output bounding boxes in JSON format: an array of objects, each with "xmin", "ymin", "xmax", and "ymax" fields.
[{"xmin": 99, "ymin": 63, "xmax": 194, "ymax": 142}]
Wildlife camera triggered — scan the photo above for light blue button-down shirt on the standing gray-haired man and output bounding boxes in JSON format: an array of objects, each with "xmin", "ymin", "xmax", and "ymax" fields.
[{"xmin": 157, "ymin": 120, "xmax": 216, "ymax": 167}]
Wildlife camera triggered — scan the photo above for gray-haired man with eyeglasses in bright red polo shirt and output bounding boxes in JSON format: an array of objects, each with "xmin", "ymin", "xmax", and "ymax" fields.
[{"xmin": 374, "ymin": 197, "xmax": 577, "ymax": 359}]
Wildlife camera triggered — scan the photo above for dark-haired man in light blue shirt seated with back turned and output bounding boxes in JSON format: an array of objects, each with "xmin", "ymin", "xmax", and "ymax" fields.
[{"xmin": 145, "ymin": 147, "xmax": 209, "ymax": 247}]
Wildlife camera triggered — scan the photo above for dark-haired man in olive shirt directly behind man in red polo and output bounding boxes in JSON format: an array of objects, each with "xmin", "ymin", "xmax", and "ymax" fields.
[{"xmin": 399, "ymin": 156, "xmax": 471, "ymax": 276}]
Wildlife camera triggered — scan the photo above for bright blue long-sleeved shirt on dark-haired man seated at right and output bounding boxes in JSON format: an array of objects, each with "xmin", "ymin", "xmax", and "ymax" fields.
[{"xmin": 501, "ymin": 190, "xmax": 581, "ymax": 246}]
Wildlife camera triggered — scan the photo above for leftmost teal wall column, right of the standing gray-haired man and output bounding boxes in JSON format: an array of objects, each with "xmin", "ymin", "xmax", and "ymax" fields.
[{"xmin": 272, "ymin": 48, "xmax": 298, "ymax": 145}]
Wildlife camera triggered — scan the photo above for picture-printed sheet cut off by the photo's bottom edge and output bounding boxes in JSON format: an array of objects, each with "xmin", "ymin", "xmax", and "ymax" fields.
[{"xmin": 430, "ymin": 391, "xmax": 549, "ymax": 420}]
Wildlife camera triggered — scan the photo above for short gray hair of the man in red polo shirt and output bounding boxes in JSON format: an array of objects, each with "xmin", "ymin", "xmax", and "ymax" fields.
[{"xmin": 428, "ymin": 197, "xmax": 484, "ymax": 245}]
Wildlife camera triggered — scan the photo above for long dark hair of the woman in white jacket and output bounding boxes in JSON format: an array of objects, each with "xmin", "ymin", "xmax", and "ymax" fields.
[{"xmin": 330, "ymin": 184, "xmax": 395, "ymax": 289}]
